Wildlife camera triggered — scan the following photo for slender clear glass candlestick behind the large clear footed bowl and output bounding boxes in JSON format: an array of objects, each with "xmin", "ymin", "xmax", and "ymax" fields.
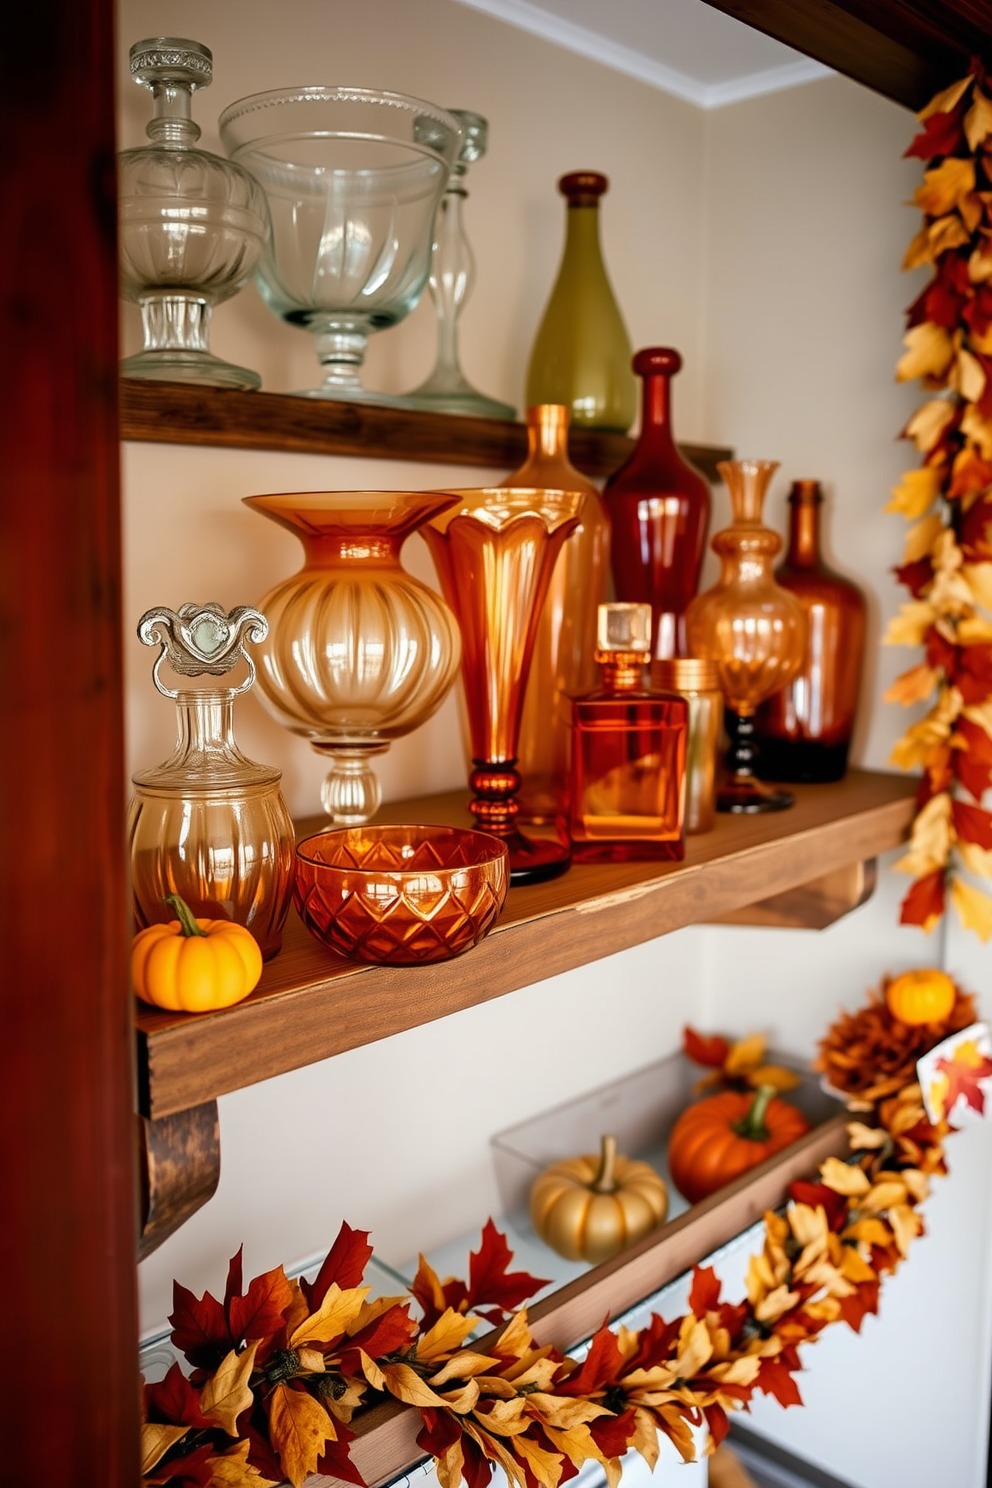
[{"xmin": 403, "ymin": 109, "xmax": 516, "ymax": 418}]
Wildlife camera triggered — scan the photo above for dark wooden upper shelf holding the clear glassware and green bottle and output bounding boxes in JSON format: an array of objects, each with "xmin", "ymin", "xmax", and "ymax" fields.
[{"xmin": 120, "ymin": 378, "xmax": 733, "ymax": 481}]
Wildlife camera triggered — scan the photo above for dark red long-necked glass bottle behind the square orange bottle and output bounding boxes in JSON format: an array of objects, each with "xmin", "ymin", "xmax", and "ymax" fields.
[{"xmin": 602, "ymin": 347, "xmax": 709, "ymax": 658}]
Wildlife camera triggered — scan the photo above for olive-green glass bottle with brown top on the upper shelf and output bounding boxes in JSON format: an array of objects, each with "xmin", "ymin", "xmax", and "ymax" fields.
[{"xmin": 526, "ymin": 171, "xmax": 637, "ymax": 433}]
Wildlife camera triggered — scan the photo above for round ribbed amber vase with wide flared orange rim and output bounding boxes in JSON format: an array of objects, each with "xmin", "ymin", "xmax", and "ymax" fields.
[{"xmin": 244, "ymin": 491, "xmax": 460, "ymax": 826}]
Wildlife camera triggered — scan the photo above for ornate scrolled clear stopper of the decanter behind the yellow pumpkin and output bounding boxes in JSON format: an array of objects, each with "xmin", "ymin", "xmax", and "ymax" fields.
[{"xmin": 138, "ymin": 601, "xmax": 269, "ymax": 698}]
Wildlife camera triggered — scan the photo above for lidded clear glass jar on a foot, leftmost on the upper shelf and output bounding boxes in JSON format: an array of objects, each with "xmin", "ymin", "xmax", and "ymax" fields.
[{"xmin": 117, "ymin": 36, "xmax": 269, "ymax": 388}]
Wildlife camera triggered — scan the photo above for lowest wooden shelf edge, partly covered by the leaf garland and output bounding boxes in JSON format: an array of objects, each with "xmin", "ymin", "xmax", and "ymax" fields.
[{"xmin": 311, "ymin": 1112, "xmax": 849, "ymax": 1488}]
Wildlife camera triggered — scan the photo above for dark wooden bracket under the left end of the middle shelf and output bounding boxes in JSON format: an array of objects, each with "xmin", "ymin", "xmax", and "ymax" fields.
[{"xmin": 137, "ymin": 1101, "xmax": 220, "ymax": 1260}]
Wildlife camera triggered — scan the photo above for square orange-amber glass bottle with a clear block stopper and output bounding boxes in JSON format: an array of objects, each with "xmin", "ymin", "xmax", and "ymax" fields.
[{"xmin": 570, "ymin": 604, "xmax": 689, "ymax": 863}]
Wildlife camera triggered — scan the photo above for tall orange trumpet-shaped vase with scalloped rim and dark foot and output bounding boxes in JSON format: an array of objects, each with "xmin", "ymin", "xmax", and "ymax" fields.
[{"xmin": 424, "ymin": 487, "xmax": 583, "ymax": 884}]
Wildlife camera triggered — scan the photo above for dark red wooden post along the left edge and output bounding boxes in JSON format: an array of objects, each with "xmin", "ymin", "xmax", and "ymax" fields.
[{"xmin": 0, "ymin": 0, "xmax": 138, "ymax": 1488}]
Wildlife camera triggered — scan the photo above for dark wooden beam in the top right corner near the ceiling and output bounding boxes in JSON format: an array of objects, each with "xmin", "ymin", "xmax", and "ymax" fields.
[{"xmin": 706, "ymin": 0, "xmax": 992, "ymax": 109}]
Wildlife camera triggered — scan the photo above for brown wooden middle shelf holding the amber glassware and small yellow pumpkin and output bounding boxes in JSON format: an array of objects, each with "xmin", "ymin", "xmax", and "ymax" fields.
[{"xmin": 137, "ymin": 771, "xmax": 915, "ymax": 1119}]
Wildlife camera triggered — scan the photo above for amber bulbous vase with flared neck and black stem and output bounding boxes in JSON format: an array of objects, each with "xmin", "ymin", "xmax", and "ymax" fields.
[{"xmin": 686, "ymin": 460, "xmax": 806, "ymax": 812}]
